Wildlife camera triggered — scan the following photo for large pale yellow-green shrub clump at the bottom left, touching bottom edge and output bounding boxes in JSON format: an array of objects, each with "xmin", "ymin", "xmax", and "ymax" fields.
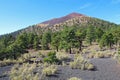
[{"xmin": 10, "ymin": 63, "xmax": 39, "ymax": 80}]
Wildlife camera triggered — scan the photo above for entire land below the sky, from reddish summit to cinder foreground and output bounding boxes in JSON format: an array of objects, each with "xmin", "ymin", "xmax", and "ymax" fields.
[{"xmin": 0, "ymin": 13, "xmax": 120, "ymax": 80}]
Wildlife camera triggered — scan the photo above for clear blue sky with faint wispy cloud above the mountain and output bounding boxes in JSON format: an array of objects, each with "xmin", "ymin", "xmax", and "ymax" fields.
[{"xmin": 0, "ymin": 0, "xmax": 120, "ymax": 35}]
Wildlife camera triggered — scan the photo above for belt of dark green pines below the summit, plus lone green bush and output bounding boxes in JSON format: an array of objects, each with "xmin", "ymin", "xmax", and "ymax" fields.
[{"xmin": 0, "ymin": 17, "xmax": 120, "ymax": 60}]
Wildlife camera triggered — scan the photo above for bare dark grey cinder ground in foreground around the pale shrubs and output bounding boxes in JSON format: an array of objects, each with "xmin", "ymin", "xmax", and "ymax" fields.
[{"xmin": 0, "ymin": 45, "xmax": 120, "ymax": 80}]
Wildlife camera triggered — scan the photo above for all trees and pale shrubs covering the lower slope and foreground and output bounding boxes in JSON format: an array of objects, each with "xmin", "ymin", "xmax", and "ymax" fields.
[{"xmin": 0, "ymin": 12, "xmax": 120, "ymax": 80}]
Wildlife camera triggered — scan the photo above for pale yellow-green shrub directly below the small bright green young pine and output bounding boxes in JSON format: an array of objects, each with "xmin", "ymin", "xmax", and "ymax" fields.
[{"xmin": 42, "ymin": 65, "xmax": 57, "ymax": 76}]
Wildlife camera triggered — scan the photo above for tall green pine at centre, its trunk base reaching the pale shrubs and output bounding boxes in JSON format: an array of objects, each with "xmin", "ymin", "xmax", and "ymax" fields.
[{"xmin": 61, "ymin": 27, "xmax": 76, "ymax": 53}]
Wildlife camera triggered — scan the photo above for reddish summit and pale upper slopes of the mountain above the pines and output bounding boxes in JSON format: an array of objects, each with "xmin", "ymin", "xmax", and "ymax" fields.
[{"xmin": 0, "ymin": 12, "xmax": 117, "ymax": 36}]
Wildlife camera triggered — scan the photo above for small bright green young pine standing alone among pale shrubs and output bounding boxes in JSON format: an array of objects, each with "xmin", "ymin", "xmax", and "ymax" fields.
[{"xmin": 44, "ymin": 52, "xmax": 58, "ymax": 63}]
